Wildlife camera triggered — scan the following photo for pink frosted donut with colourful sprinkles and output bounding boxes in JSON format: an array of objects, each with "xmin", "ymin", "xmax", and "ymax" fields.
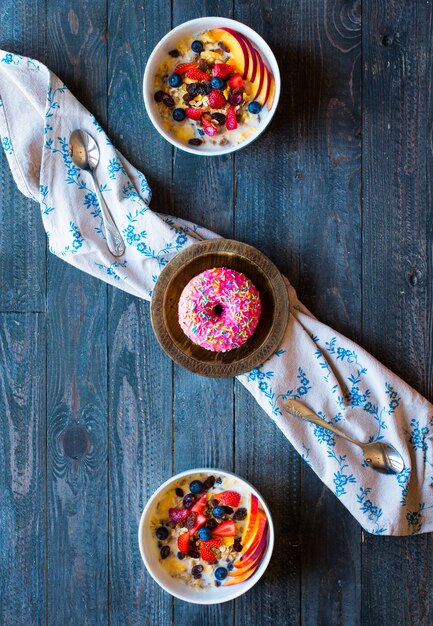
[{"xmin": 178, "ymin": 267, "xmax": 262, "ymax": 352}]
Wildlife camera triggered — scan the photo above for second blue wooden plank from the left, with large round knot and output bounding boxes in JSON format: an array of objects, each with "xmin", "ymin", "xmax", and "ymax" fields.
[{"xmin": 47, "ymin": 0, "xmax": 108, "ymax": 626}]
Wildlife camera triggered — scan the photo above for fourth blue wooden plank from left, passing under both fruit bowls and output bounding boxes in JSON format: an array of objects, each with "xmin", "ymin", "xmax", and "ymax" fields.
[{"xmin": 173, "ymin": 0, "xmax": 234, "ymax": 626}]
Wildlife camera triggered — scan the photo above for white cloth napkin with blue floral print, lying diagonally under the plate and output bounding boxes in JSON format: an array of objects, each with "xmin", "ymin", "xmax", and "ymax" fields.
[{"xmin": 0, "ymin": 51, "xmax": 433, "ymax": 535}]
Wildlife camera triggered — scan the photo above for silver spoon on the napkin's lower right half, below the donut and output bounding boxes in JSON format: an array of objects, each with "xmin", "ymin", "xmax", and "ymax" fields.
[{"xmin": 284, "ymin": 400, "xmax": 404, "ymax": 474}]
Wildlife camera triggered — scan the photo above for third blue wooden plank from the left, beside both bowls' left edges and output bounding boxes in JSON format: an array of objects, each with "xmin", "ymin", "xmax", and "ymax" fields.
[{"xmin": 108, "ymin": 0, "xmax": 172, "ymax": 626}]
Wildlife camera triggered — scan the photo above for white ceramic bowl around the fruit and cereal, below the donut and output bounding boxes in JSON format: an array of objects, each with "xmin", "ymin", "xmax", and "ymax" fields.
[{"xmin": 138, "ymin": 468, "xmax": 274, "ymax": 604}]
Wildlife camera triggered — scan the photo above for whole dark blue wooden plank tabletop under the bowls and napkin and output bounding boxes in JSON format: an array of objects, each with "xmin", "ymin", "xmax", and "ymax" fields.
[{"xmin": 0, "ymin": 0, "xmax": 433, "ymax": 626}]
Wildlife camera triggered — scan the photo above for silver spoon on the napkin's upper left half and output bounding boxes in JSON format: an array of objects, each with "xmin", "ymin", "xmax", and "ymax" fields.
[{"xmin": 69, "ymin": 130, "xmax": 125, "ymax": 256}]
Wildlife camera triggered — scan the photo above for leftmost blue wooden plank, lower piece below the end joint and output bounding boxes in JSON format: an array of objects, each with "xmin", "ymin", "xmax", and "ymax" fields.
[{"xmin": 0, "ymin": 313, "xmax": 46, "ymax": 626}]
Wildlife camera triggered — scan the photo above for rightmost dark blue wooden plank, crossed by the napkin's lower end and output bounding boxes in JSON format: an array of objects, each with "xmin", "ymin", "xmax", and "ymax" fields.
[{"xmin": 362, "ymin": 1, "xmax": 433, "ymax": 626}]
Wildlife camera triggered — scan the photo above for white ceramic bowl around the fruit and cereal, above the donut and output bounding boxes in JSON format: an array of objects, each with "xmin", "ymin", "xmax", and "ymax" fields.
[{"xmin": 143, "ymin": 17, "xmax": 281, "ymax": 156}]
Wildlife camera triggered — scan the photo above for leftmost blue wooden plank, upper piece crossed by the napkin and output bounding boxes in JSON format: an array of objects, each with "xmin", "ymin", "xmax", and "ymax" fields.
[{"xmin": 0, "ymin": 0, "xmax": 46, "ymax": 312}]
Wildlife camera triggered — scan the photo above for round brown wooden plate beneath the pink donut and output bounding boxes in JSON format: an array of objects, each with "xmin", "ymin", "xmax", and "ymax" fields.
[{"xmin": 150, "ymin": 239, "xmax": 289, "ymax": 378}]
